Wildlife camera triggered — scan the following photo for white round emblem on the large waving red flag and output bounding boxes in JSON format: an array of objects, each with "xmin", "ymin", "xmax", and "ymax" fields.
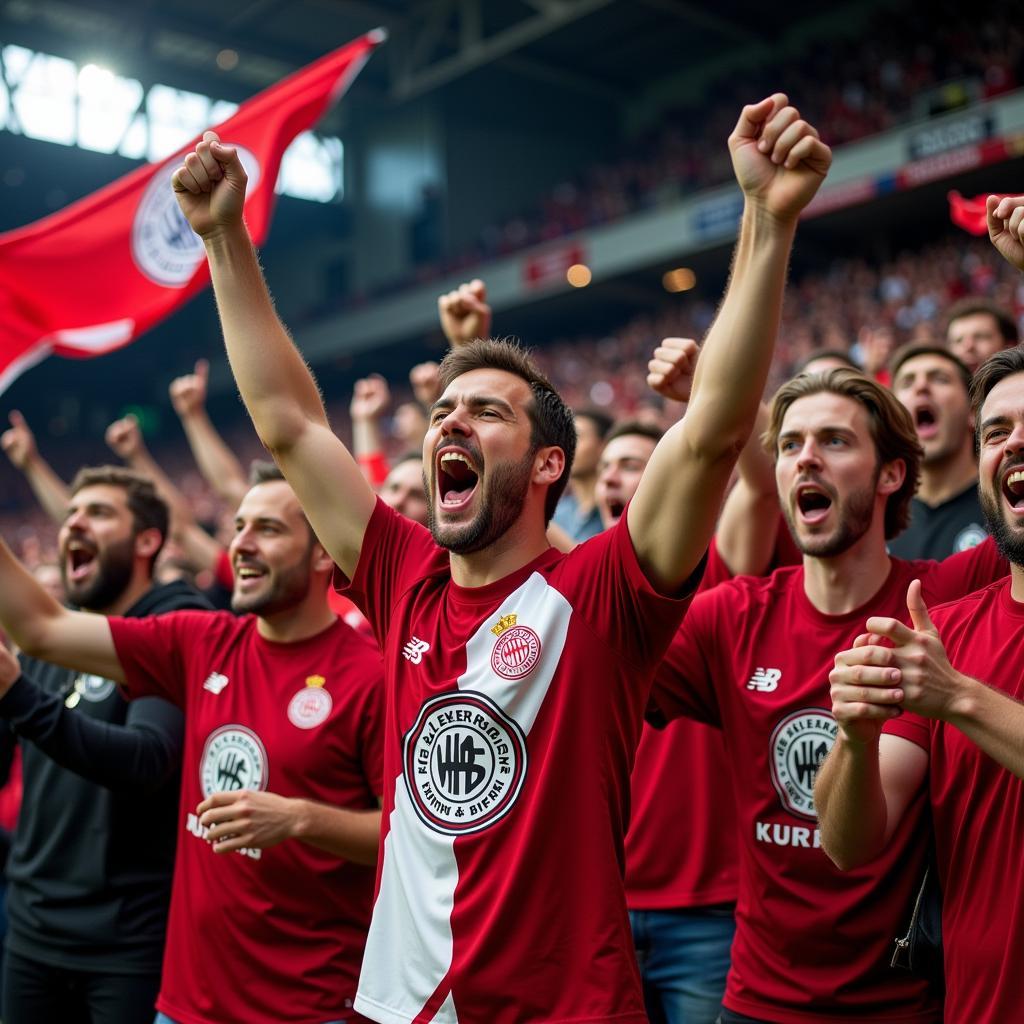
[{"xmin": 131, "ymin": 145, "xmax": 259, "ymax": 288}]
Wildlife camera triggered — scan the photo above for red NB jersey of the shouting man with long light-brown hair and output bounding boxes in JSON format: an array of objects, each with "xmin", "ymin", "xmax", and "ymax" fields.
[{"xmin": 652, "ymin": 542, "xmax": 1007, "ymax": 1024}]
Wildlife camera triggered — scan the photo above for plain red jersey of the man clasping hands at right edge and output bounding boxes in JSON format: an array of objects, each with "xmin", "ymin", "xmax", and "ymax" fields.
[{"xmin": 885, "ymin": 580, "xmax": 1024, "ymax": 1022}]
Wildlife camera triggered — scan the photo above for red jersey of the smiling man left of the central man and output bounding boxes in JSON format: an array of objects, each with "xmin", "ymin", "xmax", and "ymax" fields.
[{"xmin": 109, "ymin": 611, "xmax": 383, "ymax": 1024}]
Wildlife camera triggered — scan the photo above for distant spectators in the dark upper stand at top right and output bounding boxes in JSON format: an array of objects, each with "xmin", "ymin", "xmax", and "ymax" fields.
[{"xmin": 409, "ymin": 0, "xmax": 1024, "ymax": 280}]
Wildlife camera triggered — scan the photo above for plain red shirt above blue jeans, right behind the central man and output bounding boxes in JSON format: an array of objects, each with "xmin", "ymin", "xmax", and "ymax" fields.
[{"xmin": 626, "ymin": 541, "xmax": 737, "ymax": 910}]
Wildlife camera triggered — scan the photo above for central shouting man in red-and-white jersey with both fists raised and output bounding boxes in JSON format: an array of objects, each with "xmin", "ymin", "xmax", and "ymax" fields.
[{"xmin": 165, "ymin": 93, "xmax": 830, "ymax": 1024}]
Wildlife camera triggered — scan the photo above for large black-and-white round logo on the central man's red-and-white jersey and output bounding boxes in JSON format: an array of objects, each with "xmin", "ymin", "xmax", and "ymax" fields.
[{"xmin": 403, "ymin": 690, "xmax": 526, "ymax": 836}]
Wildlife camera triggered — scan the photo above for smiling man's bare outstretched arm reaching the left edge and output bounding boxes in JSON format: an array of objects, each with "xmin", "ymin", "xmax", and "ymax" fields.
[{"xmin": 0, "ymin": 541, "xmax": 124, "ymax": 682}]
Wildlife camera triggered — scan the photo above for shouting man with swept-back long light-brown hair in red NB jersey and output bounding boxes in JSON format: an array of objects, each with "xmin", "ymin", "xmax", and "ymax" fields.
[{"xmin": 649, "ymin": 369, "xmax": 1006, "ymax": 1024}]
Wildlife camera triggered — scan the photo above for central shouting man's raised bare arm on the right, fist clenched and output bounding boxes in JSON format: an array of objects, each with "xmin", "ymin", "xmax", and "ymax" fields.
[{"xmin": 627, "ymin": 93, "xmax": 831, "ymax": 593}]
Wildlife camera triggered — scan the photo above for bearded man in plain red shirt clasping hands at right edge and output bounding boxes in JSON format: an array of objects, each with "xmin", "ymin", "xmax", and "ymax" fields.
[{"xmin": 817, "ymin": 196, "xmax": 1024, "ymax": 1021}]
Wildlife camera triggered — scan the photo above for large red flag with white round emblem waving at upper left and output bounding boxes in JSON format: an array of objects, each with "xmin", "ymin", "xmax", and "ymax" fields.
[{"xmin": 0, "ymin": 30, "xmax": 384, "ymax": 392}]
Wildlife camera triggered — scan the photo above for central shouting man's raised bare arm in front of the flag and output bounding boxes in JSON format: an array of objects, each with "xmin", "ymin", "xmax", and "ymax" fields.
[{"xmin": 172, "ymin": 132, "xmax": 376, "ymax": 575}]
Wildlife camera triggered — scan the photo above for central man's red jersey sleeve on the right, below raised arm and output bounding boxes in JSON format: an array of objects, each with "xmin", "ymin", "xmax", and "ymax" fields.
[{"xmin": 559, "ymin": 513, "xmax": 707, "ymax": 673}]
